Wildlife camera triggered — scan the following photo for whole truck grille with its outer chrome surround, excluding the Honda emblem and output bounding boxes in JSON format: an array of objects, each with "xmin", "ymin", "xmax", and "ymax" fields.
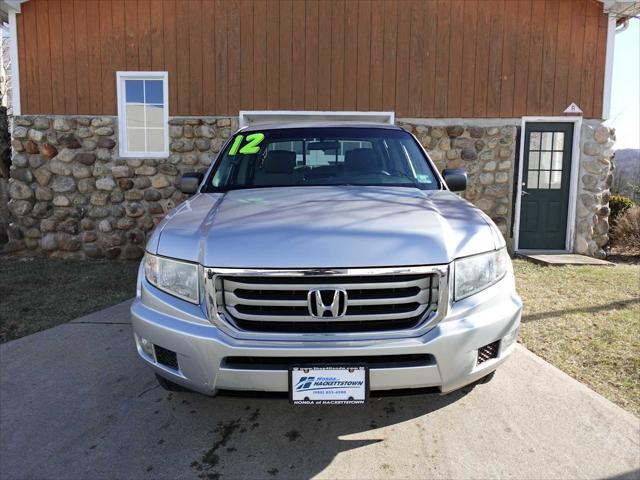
[{"xmin": 203, "ymin": 265, "xmax": 450, "ymax": 342}]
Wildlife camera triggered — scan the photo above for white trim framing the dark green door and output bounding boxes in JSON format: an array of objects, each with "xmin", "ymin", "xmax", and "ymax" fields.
[{"xmin": 513, "ymin": 116, "xmax": 582, "ymax": 252}]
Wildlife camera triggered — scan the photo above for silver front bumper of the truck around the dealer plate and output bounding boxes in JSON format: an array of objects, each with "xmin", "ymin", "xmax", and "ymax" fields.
[{"xmin": 131, "ymin": 266, "xmax": 522, "ymax": 395}]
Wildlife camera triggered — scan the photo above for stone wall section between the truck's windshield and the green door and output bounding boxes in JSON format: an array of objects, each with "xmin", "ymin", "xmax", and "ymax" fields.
[{"xmin": 397, "ymin": 119, "xmax": 517, "ymax": 239}]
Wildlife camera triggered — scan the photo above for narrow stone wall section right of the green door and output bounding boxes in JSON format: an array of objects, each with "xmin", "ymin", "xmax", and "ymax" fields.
[{"xmin": 574, "ymin": 120, "xmax": 615, "ymax": 258}]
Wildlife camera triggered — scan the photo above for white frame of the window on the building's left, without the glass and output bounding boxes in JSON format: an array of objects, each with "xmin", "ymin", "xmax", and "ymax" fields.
[{"xmin": 116, "ymin": 71, "xmax": 169, "ymax": 158}]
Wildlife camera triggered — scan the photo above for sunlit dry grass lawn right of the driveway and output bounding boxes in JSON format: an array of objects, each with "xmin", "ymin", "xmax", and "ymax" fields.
[{"xmin": 514, "ymin": 260, "xmax": 640, "ymax": 415}]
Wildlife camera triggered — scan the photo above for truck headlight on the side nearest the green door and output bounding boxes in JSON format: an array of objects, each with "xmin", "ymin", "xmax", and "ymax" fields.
[{"xmin": 454, "ymin": 248, "xmax": 511, "ymax": 300}]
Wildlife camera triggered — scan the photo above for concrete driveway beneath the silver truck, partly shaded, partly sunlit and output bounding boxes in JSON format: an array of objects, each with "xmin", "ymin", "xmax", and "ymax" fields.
[{"xmin": 0, "ymin": 303, "xmax": 640, "ymax": 479}]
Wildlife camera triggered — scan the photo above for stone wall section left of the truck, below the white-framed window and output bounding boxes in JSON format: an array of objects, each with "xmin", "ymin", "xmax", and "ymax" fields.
[{"xmin": 4, "ymin": 116, "xmax": 238, "ymax": 259}]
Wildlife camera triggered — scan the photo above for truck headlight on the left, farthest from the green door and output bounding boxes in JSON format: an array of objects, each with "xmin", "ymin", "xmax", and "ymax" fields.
[{"xmin": 144, "ymin": 253, "xmax": 200, "ymax": 303}]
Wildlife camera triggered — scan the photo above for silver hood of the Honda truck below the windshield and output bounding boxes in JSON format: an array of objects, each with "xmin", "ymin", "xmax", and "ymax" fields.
[{"xmin": 147, "ymin": 186, "xmax": 504, "ymax": 268}]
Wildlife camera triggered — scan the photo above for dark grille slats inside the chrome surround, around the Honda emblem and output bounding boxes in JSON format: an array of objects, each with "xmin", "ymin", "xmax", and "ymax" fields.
[{"xmin": 218, "ymin": 273, "xmax": 438, "ymax": 333}]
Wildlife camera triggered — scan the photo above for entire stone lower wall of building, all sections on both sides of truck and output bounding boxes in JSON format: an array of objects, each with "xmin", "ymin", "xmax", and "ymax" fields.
[{"xmin": 4, "ymin": 116, "xmax": 614, "ymax": 259}]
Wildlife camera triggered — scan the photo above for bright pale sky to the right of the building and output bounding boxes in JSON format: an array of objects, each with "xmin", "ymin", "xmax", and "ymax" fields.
[{"xmin": 609, "ymin": 18, "xmax": 640, "ymax": 149}]
